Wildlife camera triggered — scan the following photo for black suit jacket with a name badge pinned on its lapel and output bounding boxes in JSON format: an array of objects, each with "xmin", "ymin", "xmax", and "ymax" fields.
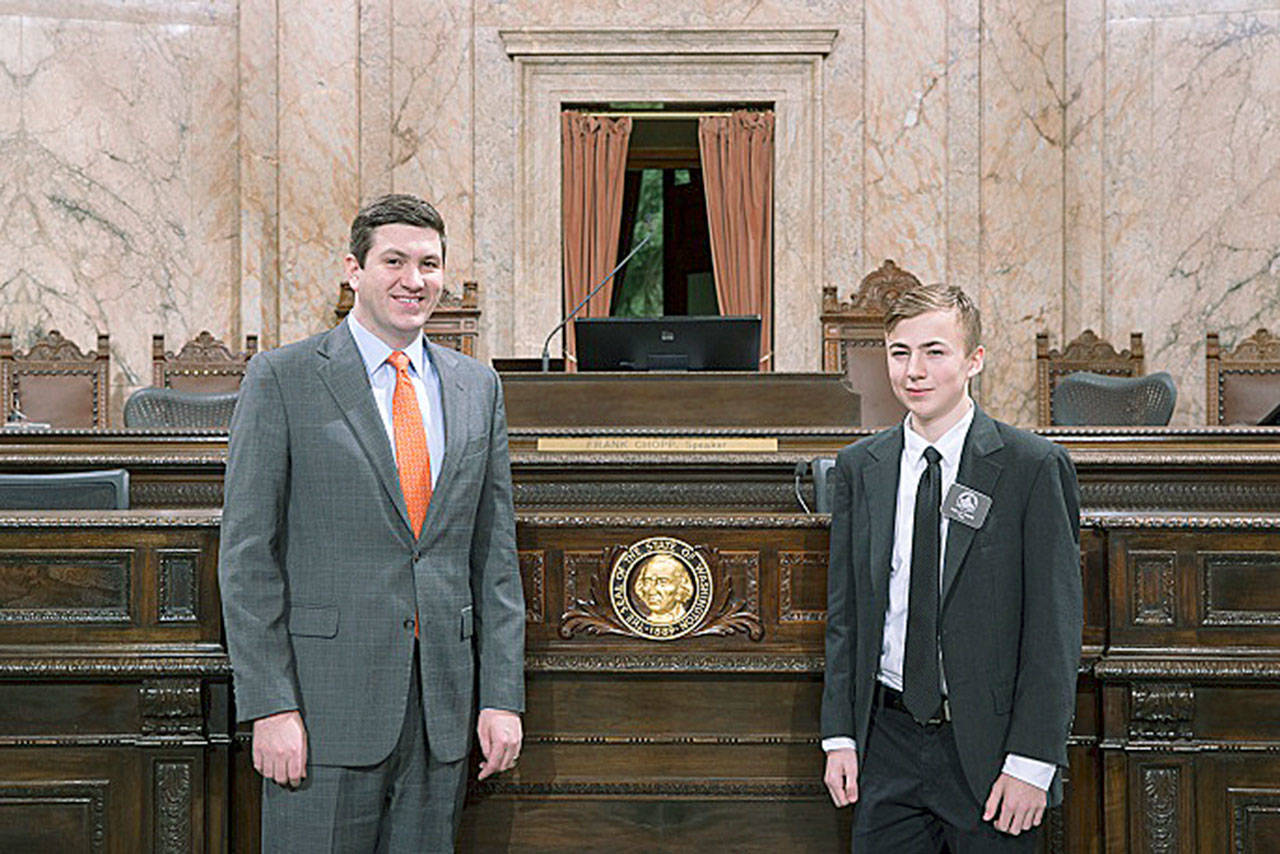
[{"xmin": 822, "ymin": 408, "xmax": 1084, "ymax": 805}]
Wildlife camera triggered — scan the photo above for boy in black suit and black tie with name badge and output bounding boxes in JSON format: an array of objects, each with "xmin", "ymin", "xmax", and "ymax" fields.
[{"xmin": 822, "ymin": 286, "xmax": 1083, "ymax": 854}]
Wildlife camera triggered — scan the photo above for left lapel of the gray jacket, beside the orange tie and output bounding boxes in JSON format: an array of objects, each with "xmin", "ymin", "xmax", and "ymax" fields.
[{"xmin": 316, "ymin": 324, "xmax": 408, "ymax": 530}]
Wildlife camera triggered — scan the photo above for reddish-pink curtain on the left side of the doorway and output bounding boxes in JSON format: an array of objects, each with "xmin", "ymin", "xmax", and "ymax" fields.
[{"xmin": 561, "ymin": 110, "xmax": 631, "ymax": 370}]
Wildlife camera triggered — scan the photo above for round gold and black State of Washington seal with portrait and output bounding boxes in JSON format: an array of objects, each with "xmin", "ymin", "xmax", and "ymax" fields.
[{"xmin": 609, "ymin": 536, "xmax": 713, "ymax": 640}]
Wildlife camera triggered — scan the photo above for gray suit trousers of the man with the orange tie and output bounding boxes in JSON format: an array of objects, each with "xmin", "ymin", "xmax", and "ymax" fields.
[{"xmin": 262, "ymin": 649, "xmax": 467, "ymax": 854}]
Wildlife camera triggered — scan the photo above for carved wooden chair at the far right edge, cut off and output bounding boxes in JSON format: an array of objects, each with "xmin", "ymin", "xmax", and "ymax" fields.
[{"xmin": 1204, "ymin": 329, "xmax": 1280, "ymax": 424}]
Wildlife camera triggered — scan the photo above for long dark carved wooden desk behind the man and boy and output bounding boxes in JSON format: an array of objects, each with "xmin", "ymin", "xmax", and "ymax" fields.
[{"xmin": 0, "ymin": 428, "xmax": 1280, "ymax": 851}]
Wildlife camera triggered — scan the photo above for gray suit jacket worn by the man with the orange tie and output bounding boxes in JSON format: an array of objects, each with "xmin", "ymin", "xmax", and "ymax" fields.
[{"xmin": 219, "ymin": 324, "xmax": 525, "ymax": 766}]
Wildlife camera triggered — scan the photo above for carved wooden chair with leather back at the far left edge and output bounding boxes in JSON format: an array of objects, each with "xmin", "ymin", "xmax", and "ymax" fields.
[{"xmin": 0, "ymin": 329, "xmax": 111, "ymax": 429}]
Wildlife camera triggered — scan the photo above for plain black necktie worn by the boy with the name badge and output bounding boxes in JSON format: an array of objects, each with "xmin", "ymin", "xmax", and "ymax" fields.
[{"xmin": 902, "ymin": 446, "xmax": 942, "ymax": 723}]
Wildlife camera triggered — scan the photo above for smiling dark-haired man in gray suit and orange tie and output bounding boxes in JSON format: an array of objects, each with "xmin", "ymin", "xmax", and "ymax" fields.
[{"xmin": 219, "ymin": 195, "xmax": 525, "ymax": 853}]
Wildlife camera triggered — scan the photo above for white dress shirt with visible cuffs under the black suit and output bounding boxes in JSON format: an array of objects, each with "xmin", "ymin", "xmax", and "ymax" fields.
[{"xmin": 822, "ymin": 401, "xmax": 1056, "ymax": 790}]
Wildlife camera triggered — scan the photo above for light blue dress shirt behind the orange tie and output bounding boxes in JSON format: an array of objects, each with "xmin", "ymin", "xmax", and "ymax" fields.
[{"xmin": 347, "ymin": 312, "xmax": 444, "ymax": 489}]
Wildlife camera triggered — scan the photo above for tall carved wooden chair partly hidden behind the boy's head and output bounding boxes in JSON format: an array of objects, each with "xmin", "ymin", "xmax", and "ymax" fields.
[{"xmin": 822, "ymin": 260, "xmax": 920, "ymax": 428}]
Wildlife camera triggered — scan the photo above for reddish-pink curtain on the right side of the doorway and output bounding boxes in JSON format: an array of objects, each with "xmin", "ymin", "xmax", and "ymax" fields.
[{"xmin": 698, "ymin": 110, "xmax": 773, "ymax": 370}]
